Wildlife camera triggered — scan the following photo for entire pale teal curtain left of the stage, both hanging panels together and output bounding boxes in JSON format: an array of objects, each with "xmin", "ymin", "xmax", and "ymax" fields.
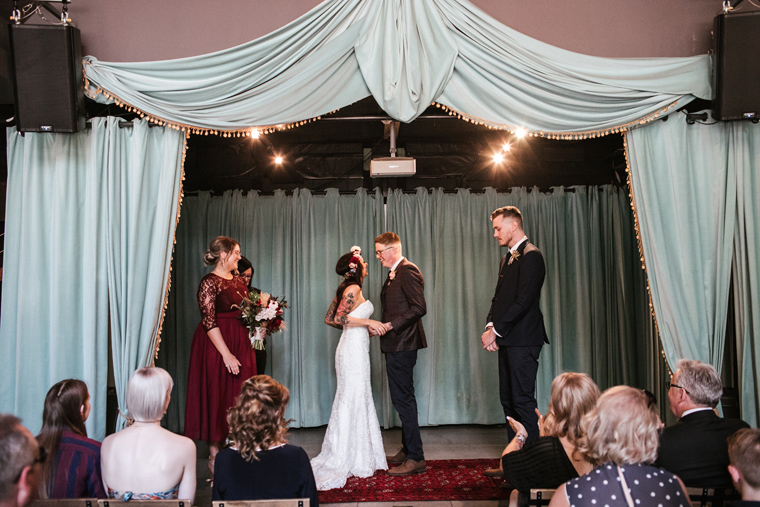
[{"xmin": 0, "ymin": 118, "xmax": 184, "ymax": 440}]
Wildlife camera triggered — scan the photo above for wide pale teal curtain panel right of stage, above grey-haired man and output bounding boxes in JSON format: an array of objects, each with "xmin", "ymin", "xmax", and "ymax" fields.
[{"xmin": 626, "ymin": 116, "xmax": 736, "ymax": 369}]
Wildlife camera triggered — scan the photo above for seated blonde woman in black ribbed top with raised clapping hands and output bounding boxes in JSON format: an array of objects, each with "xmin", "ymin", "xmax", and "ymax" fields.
[{"xmin": 502, "ymin": 373, "xmax": 600, "ymax": 503}]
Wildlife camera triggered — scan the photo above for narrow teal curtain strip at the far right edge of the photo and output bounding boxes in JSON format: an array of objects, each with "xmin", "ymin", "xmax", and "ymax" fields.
[{"xmin": 727, "ymin": 122, "xmax": 760, "ymax": 428}]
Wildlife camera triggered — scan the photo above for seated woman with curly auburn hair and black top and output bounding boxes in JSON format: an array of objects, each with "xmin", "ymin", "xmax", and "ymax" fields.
[{"xmin": 212, "ymin": 375, "xmax": 319, "ymax": 507}]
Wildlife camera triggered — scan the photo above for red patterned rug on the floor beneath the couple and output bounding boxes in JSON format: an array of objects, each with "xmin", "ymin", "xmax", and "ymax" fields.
[{"xmin": 319, "ymin": 459, "xmax": 510, "ymax": 503}]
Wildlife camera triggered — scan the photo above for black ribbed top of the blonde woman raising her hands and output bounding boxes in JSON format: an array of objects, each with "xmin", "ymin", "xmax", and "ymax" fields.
[{"xmin": 501, "ymin": 437, "xmax": 578, "ymax": 493}]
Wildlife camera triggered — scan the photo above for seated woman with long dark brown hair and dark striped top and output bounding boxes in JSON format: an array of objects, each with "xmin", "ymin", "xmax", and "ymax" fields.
[{"xmin": 37, "ymin": 379, "xmax": 107, "ymax": 498}]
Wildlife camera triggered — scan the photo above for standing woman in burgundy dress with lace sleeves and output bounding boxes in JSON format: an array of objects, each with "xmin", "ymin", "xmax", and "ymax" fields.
[{"xmin": 185, "ymin": 236, "xmax": 256, "ymax": 473}]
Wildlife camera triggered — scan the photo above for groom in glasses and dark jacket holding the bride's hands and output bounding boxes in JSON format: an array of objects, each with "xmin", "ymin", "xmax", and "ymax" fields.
[{"xmin": 370, "ymin": 232, "xmax": 427, "ymax": 475}]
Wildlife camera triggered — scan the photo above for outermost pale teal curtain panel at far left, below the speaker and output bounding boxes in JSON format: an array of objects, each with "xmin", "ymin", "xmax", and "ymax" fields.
[{"xmin": 0, "ymin": 119, "xmax": 108, "ymax": 439}]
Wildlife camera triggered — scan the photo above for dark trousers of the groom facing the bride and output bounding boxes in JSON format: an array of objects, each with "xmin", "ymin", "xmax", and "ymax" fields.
[{"xmin": 385, "ymin": 350, "xmax": 425, "ymax": 461}]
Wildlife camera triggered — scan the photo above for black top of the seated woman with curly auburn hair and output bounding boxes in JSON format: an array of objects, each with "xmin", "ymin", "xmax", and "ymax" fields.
[{"xmin": 212, "ymin": 444, "xmax": 319, "ymax": 507}]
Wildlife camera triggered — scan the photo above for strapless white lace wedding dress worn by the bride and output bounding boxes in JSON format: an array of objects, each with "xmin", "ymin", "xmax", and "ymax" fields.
[{"xmin": 311, "ymin": 301, "xmax": 388, "ymax": 491}]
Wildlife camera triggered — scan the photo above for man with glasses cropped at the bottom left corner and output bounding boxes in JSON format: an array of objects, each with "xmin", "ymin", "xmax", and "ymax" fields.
[{"xmin": 0, "ymin": 414, "xmax": 46, "ymax": 507}]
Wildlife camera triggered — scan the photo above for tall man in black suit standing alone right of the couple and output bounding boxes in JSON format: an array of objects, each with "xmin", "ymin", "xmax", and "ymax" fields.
[{"xmin": 481, "ymin": 206, "xmax": 549, "ymax": 475}]
